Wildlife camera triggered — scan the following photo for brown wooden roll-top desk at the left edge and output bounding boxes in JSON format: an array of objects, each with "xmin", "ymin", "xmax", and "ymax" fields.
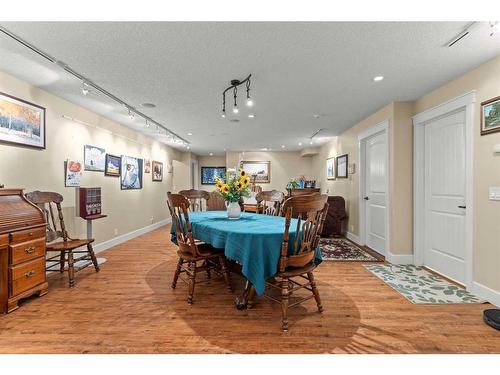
[{"xmin": 0, "ymin": 189, "xmax": 48, "ymax": 313}]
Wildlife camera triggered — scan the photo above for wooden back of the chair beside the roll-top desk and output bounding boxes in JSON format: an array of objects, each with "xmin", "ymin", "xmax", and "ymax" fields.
[{"xmin": 26, "ymin": 190, "xmax": 71, "ymax": 242}]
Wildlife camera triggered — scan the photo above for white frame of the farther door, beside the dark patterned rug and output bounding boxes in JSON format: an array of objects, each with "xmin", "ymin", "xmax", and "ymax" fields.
[{"xmin": 358, "ymin": 119, "xmax": 391, "ymax": 257}]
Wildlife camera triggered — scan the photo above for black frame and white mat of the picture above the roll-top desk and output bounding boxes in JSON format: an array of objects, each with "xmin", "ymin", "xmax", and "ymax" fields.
[{"xmin": 0, "ymin": 92, "xmax": 47, "ymax": 150}]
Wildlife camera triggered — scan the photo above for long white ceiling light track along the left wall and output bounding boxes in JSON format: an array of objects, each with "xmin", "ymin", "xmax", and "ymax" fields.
[{"xmin": 0, "ymin": 26, "xmax": 189, "ymax": 145}]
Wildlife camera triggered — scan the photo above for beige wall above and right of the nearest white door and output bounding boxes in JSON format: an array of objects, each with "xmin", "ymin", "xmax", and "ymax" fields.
[{"xmin": 414, "ymin": 57, "xmax": 500, "ymax": 291}]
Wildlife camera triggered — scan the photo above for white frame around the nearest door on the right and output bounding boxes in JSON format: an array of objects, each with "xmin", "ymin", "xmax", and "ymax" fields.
[{"xmin": 413, "ymin": 91, "xmax": 476, "ymax": 289}]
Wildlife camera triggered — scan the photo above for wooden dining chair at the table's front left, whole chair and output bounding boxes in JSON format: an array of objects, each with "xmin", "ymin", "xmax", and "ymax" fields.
[{"xmin": 167, "ymin": 192, "xmax": 232, "ymax": 305}]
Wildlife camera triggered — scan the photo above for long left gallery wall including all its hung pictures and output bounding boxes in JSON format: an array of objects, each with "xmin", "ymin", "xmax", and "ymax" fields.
[{"xmin": 0, "ymin": 72, "xmax": 182, "ymax": 243}]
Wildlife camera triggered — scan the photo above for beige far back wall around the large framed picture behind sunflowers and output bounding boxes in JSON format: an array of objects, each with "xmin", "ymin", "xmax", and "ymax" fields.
[{"xmin": 226, "ymin": 151, "xmax": 316, "ymax": 192}]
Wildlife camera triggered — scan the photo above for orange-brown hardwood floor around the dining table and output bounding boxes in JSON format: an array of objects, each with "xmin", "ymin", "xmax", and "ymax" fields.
[{"xmin": 0, "ymin": 227, "xmax": 500, "ymax": 353}]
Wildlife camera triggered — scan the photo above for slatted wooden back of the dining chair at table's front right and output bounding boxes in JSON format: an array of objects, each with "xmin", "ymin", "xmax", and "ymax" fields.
[{"xmin": 279, "ymin": 195, "xmax": 328, "ymax": 272}]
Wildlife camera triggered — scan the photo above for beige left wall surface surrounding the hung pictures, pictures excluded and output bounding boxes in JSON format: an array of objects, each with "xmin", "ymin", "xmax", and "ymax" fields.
[{"xmin": 0, "ymin": 72, "xmax": 186, "ymax": 247}]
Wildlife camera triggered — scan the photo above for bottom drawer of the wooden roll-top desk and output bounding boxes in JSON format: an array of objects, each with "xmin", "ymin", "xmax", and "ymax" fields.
[{"xmin": 10, "ymin": 258, "xmax": 45, "ymax": 296}]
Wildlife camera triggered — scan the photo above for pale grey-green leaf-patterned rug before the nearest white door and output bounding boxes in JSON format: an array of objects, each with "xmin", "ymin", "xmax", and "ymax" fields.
[{"xmin": 364, "ymin": 264, "xmax": 486, "ymax": 304}]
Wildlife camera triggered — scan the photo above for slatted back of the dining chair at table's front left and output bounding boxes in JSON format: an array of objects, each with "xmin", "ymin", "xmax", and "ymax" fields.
[{"xmin": 167, "ymin": 192, "xmax": 207, "ymax": 257}]
